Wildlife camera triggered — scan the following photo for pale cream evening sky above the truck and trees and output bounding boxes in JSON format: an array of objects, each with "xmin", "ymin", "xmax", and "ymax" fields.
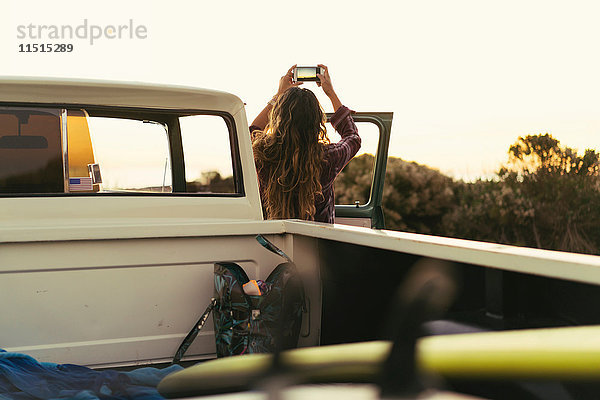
[{"xmin": 0, "ymin": 0, "xmax": 600, "ymax": 179}]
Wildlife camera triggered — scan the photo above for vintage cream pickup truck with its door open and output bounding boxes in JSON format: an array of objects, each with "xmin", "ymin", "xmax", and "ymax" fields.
[{"xmin": 0, "ymin": 78, "xmax": 600, "ymax": 396}]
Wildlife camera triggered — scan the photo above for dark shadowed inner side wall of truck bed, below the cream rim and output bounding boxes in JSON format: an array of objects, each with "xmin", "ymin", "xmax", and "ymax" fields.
[{"xmin": 319, "ymin": 240, "xmax": 600, "ymax": 344}]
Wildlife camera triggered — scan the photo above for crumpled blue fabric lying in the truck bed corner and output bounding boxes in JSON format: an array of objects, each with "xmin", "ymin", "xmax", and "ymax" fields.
[{"xmin": 0, "ymin": 349, "xmax": 183, "ymax": 400}]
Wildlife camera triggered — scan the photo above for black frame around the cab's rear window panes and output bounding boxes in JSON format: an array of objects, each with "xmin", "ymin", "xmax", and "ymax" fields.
[{"xmin": 0, "ymin": 102, "xmax": 246, "ymax": 198}]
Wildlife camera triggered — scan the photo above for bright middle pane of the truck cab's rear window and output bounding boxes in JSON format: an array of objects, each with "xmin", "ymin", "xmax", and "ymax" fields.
[{"xmin": 85, "ymin": 117, "xmax": 172, "ymax": 193}]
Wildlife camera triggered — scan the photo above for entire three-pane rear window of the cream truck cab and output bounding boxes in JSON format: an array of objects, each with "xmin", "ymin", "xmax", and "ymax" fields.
[{"xmin": 0, "ymin": 106, "xmax": 244, "ymax": 196}]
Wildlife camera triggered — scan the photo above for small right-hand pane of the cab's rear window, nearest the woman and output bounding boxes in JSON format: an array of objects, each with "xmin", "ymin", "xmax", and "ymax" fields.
[{"xmin": 179, "ymin": 115, "xmax": 236, "ymax": 193}]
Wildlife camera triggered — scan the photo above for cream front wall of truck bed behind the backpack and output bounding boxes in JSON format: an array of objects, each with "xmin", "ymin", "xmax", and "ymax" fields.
[{"xmin": 0, "ymin": 235, "xmax": 320, "ymax": 366}]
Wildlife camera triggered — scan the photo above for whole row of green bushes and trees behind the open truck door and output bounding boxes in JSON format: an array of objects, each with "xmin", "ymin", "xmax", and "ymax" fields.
[{"xmin": 336, "ymin": 134, "xmax": 600, "ymax": 254}]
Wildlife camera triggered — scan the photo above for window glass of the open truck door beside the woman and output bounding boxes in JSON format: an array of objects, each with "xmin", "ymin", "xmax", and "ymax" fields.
[{"xmin": 327, "ymin": 122, "xmax": 379, "ymax": 205}]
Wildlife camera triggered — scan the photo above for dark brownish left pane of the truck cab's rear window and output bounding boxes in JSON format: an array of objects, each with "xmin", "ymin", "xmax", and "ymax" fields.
[{"xmin": 0, "ymin": 107, "xmax": 64, "ymax": 193}]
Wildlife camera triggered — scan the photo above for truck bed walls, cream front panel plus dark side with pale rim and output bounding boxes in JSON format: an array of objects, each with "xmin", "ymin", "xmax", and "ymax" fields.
[{"xmin": 0, "ymin": 221, "xmax": 600, "ymax": 366}]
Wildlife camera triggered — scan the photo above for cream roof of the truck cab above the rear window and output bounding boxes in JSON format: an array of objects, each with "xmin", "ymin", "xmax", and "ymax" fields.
[{"xmin": 0, "ymin": 77, "xmax": 244, "ymax": 115}]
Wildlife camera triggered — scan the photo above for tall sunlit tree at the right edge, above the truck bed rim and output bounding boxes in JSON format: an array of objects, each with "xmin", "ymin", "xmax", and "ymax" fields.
[{"xmin": 444, "ymin": 134, "xmax": 600, "ymax": 254}]
